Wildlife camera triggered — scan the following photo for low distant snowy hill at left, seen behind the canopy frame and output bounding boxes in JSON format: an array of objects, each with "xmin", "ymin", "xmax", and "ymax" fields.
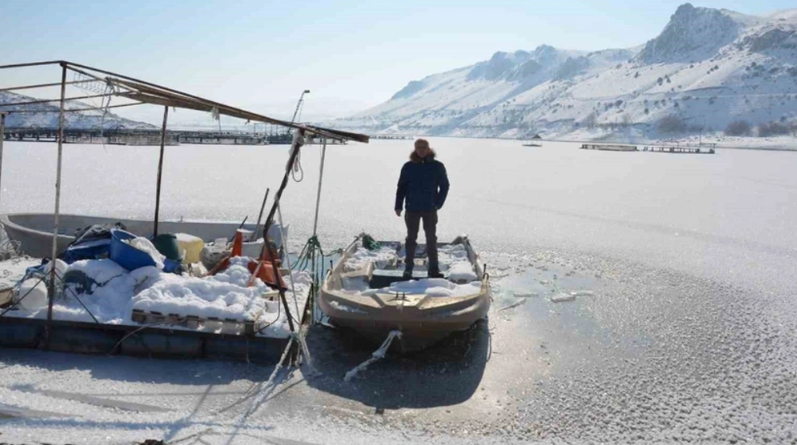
[{"xmin": 0, "ymin": 92, "xmax": 157, "ymax": 129}]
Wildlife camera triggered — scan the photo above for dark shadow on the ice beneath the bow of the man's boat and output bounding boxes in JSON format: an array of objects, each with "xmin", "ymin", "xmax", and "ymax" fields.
[{"xmin": 302, "ymin": 319, "xmax": 491, "ymax": 410}]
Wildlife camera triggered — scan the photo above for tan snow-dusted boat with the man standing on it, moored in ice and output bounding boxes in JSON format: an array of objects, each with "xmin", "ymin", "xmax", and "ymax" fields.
[{"xmin": 318, "ymin": 236, "xmax": 491, "ymax": 351}]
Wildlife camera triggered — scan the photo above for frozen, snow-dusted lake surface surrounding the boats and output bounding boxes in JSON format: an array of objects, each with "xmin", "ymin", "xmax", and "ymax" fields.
[{"xmin": 0, "ymin": 139, "xmax": 797, "ymax": 443}]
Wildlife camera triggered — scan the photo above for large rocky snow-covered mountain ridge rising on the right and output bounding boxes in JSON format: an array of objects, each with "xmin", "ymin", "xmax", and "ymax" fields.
[{"xmin": 334, "ymin": 4, "xmax": 797, "ymax": 139}]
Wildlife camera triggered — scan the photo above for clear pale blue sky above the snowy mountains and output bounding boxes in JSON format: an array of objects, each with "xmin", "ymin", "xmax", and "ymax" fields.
[{"xmin": 0, "ymin": 0, "xmax": 797, "ymax": 121}]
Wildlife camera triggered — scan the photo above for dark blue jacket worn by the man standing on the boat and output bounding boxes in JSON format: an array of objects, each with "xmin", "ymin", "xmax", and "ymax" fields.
[{"xmin": 396, "ymin": 150, "xmax": 448, "ymax": 212}]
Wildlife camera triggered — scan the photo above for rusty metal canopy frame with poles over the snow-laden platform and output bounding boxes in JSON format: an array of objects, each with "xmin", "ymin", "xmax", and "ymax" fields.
[{"xmin": 0, "ymin": 60, "xmax": 369, "ymax": 345}]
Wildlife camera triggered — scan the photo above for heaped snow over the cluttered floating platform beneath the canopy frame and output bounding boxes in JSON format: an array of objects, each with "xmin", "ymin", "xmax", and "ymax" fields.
[{"xmin": 6, "ymin": 257, "xmax": 311, "ymax": 337}]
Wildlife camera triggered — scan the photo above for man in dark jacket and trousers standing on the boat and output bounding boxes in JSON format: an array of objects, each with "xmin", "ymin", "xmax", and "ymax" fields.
[{"xmin": 396, "ymin": 139, "xmax": 449, "ymax": 279}]
